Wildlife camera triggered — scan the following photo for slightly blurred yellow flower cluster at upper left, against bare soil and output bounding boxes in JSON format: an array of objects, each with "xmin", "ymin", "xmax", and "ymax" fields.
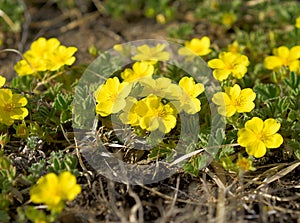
[{"xmin": 14, "ymin": 37, "xmax": 77, "ymax": 77}]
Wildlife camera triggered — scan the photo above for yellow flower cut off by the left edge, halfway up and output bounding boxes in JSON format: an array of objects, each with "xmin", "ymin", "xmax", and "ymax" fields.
[{"xmin": 0, "ymin": 89, "xmax": 28, "ymax": 126}]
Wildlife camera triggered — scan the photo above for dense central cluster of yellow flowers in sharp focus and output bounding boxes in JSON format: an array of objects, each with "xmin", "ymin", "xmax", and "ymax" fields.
[{"xmin": 94, "ymin": 54, "xmax": 204, "ymax": 133}]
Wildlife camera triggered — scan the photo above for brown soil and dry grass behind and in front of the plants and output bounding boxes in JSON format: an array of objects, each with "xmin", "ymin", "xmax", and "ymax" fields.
[{"xmin": 0, "ymin": 1, "xmax": 300, "ymax": 223}]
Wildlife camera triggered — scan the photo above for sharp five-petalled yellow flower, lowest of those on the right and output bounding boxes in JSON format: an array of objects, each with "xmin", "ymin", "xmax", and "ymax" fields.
[{"xmin": 238, "ymin": 117, "xmax": 283, "ymax": 158}]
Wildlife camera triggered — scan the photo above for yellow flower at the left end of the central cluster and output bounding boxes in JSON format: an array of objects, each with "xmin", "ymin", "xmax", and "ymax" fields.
[{"xmin": 94, "ymin": 77, "xmax": 131, "ymax": 117}]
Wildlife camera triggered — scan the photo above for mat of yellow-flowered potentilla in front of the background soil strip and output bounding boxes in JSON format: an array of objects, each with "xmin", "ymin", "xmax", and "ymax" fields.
[{"xmin": 0, "ymin": 32, "xmax": 300, "ymax": 222}]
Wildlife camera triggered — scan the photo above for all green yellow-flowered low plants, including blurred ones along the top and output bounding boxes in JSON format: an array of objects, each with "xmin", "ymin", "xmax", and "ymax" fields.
[{"xmin": 0, "ymin": 0, "xmax": 300, "ymax": 222}]
